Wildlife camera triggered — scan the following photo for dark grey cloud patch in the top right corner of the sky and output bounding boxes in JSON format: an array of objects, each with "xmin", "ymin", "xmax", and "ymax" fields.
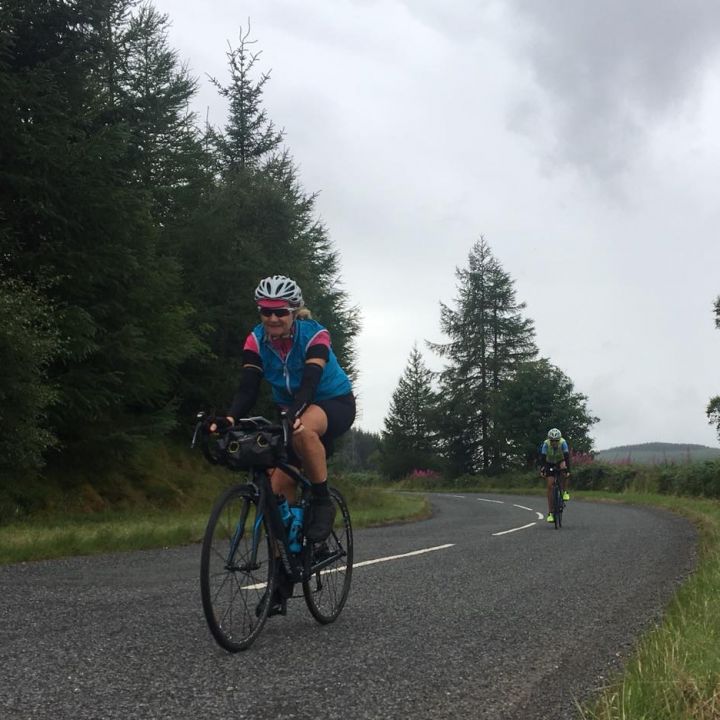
[{"xmin": 508, "ymin": 0, "xmax": 720, "ymax": 176}]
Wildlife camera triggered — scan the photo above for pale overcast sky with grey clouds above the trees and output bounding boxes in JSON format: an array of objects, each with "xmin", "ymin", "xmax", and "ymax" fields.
[{"xmin": 153, "ymin": 0, "xmax": 720, "ymax": 449}]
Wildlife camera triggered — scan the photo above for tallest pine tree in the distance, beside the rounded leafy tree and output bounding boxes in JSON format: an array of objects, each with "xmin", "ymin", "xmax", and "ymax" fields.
[{"xmin": 429, "ymin": 237, "xmax": 537, "ymax": 473}]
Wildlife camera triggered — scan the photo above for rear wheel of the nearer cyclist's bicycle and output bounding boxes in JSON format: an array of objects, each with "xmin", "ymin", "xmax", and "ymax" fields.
[{"xmin": 302, "ymin": 488, "xmax": 353, "ymax": 625}]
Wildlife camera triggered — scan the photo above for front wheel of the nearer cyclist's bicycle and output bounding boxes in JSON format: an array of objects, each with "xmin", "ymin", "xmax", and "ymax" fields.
[{"xmin": 200, "ymin": 485, "xmax": 275, "ymax": 652}]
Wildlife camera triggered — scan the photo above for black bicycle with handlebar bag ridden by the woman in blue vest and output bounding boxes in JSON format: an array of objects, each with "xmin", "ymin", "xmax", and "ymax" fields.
[{"xmin": 192, "ymin": 413, "xmax": 353, "ymax": 652}]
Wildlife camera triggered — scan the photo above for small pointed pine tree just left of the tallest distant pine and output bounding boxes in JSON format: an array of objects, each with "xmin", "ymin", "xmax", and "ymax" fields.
[{"xmin": 382, "ymin": 345, "xmax": 437, "ymax": 477}]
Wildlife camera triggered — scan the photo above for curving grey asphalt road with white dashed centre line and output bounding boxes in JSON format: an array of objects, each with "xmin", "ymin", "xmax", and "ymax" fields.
[{"xmin": 0, "ymin": 495, "xmax": 696, "ymax": 720}]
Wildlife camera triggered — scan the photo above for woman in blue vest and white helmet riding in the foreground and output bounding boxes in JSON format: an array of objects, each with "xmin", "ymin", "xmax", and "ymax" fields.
[{"xmin": 210, "ymin": 275, "xmax": 355, "ymax": 542}]
